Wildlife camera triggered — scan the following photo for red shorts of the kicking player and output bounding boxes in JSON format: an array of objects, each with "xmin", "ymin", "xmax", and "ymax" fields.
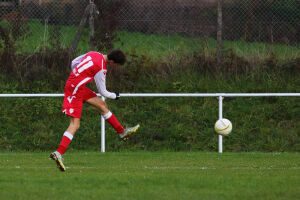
[{"xmin": 62, "ymin": 82, "xmax": 97, "ymax": 118}]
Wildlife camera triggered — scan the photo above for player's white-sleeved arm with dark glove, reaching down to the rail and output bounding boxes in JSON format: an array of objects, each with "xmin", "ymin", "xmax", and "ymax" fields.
[{"xmin": 94, "ymin": 70, "xmax": 119, "ymax": 99}]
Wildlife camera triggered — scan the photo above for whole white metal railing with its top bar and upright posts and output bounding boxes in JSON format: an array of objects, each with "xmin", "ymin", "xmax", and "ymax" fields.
[{"xmin": 0, "ymin": 93, "xmax": 300, "ymax": 153}]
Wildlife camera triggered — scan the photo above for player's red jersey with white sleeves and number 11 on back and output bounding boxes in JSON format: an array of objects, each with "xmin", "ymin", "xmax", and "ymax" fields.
[{"xmin": 68, "ymin": 51, "xmax": 116, "ymax": 99}]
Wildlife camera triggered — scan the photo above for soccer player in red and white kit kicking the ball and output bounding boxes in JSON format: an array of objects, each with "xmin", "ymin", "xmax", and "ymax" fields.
[{"xmin": 50, "ymin": 50, "xmax": 139, "ymax": 171}]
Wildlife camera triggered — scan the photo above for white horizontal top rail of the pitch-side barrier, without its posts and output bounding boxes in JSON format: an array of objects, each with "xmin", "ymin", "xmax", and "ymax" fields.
[{"xmin": 0, "ymin": 93, "xmax": 300, "ymax": 98}]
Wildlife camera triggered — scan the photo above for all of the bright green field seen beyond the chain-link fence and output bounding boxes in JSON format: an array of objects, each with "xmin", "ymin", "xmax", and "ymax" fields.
[{"xmin": 5, "ymin": 20, "xmax": 300, "ymax": 60}]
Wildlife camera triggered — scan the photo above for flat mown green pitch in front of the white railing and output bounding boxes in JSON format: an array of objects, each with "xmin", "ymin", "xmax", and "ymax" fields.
[{"xmin": 0, "ymin": 152, "xmax": 300, "ymax": 200}]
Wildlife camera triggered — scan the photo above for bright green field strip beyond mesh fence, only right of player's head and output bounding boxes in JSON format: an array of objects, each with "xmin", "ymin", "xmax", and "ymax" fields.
[{"xmin": 115, "ymin": 31, "xmax": 300, "ymax": 60}]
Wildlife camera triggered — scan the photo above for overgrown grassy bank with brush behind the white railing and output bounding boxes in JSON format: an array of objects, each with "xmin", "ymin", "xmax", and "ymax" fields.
[{"xmin": 0, "ymin": 48, "xmax": 300, "ymax": 151}]
